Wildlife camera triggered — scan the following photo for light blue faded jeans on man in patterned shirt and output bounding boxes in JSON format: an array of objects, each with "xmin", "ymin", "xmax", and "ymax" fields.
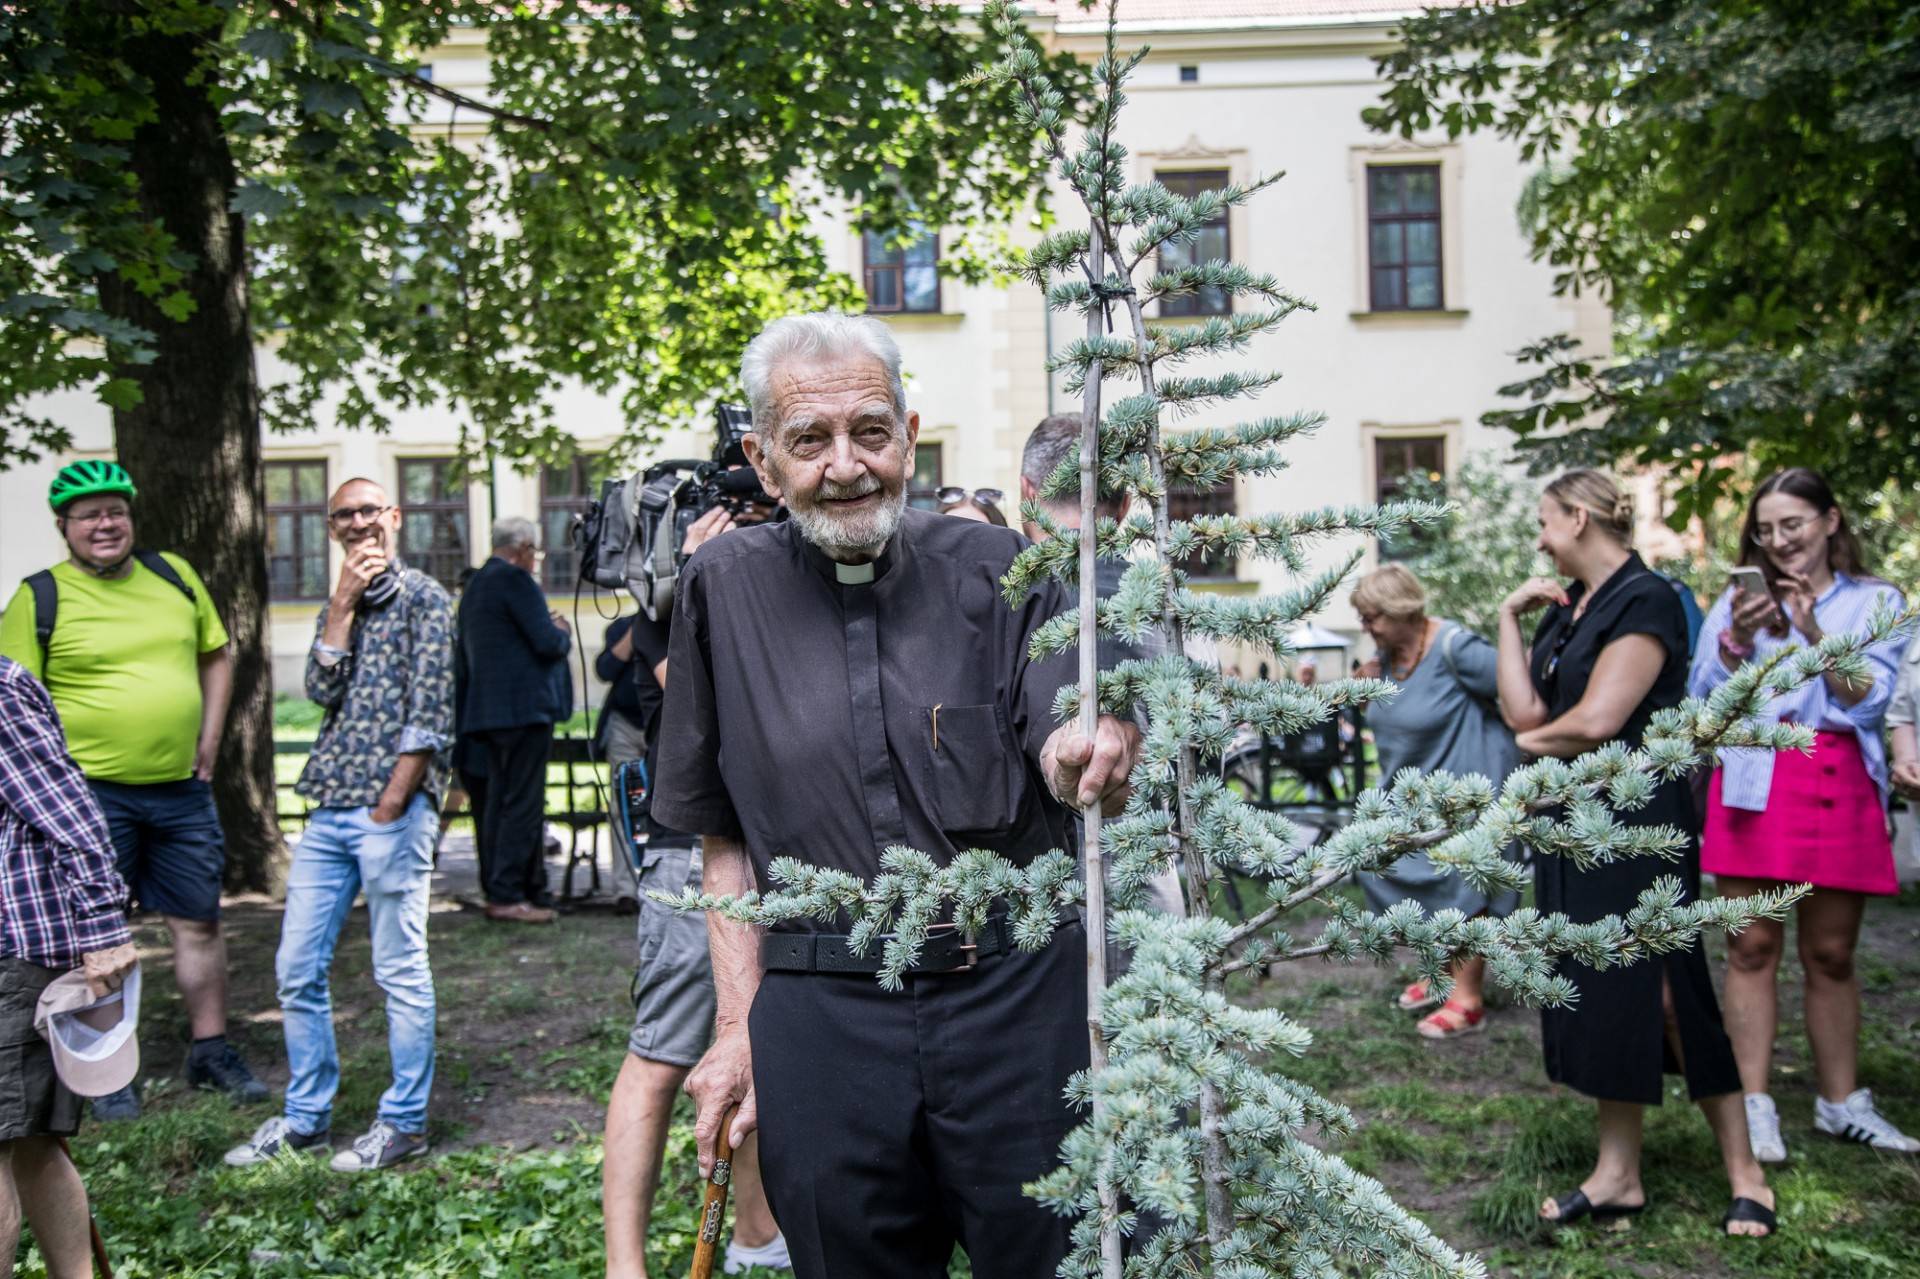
[{"xmin": 275, "ymin": 793, "xmax": 440, "ymax": 1133}]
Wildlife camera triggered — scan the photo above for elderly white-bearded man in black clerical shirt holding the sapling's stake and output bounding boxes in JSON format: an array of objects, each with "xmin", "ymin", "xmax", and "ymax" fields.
[{"xmin": 653, "ymin": 315, "xmax": 1139, "ymax": 1279}]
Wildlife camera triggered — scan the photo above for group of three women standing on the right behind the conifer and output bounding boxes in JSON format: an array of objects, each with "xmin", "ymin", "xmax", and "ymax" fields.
[{"xmin": 1352, "ymin": 469, "xmax": 1920, "ymax": 1235}]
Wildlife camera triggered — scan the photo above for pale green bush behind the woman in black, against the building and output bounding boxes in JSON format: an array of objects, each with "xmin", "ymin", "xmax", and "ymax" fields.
[{"xmin": 1400, "ymin": 453, "xmax": 1540, "ymax": 640}]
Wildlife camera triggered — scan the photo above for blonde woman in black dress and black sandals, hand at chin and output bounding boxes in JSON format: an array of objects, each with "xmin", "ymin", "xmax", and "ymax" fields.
[{"xmin": 1500, "ymin": 471, "xmax": 1774, "ymax": 1235}]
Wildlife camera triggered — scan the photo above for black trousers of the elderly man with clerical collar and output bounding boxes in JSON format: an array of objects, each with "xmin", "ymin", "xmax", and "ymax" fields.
[{"xmin": 747, "ymin": 924, "xmax": 1087, "ymax": 1279}]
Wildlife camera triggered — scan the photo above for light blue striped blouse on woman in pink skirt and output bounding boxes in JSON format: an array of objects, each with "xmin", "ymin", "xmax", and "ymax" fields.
[{"xmin": 1688, "ymin": 572, "xmax": 1907, "ymax": 812}]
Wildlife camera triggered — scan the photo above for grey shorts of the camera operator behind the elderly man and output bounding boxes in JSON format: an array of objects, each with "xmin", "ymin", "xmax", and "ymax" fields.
[{"xmin": 626, "ymin": 839, "xmax": 714, "ymax": 1066}]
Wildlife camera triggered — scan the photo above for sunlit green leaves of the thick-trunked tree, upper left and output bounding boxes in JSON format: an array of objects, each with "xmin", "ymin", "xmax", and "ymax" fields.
[{"xmin": 0, "ymin": 0, "xmax": 1075, "ymax": 465}]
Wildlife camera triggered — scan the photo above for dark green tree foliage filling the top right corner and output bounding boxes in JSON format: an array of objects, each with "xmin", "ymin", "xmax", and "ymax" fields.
[{"xmin": 1367, "ymin": 0, "xmax": 1920, "ymax": 519}]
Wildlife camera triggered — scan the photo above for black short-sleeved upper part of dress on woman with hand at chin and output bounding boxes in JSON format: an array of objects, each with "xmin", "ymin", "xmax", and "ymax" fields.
[{"xmin": 1532, "ymin": 553, "xmax": 1688, "ymax": 747}]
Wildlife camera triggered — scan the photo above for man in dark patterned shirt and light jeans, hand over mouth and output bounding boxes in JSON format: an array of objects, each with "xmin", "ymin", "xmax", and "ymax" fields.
[{"xmin": 227, "ymin": 480, "xmax": 453, "ymax": 1171}]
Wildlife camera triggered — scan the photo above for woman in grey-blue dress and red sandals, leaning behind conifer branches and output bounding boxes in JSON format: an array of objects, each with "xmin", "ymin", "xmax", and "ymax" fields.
[{"xmin": 1352, "ymin": 565, "xmax": 1519, "ymax": 1039}]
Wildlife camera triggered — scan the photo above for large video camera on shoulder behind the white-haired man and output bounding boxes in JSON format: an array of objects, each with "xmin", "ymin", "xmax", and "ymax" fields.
[{"xmin": 574, "ymin": 403, "xmax": 787, "ymax": 622}]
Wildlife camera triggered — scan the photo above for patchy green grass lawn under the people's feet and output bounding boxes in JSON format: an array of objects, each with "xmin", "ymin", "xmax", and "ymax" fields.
[{"xmin": 21, "ymin": 852, "xmax": 1920, "ymax": 1279}]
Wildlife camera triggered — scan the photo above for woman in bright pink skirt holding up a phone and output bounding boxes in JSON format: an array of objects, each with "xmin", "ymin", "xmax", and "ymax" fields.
[{"xmin": 1690, "ymin": 469, "xmax": 1920, "ymax": 1164}]
